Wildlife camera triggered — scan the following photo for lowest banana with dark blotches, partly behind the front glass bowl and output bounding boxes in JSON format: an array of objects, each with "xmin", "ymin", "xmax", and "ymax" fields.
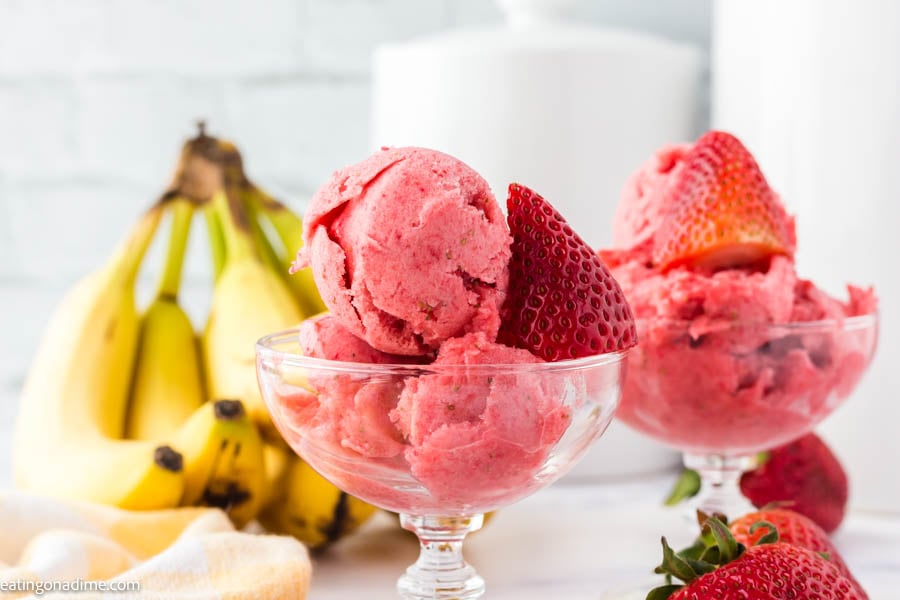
[{"xmin": 259, "ymin": 456, "xmax": 377, "ymax": 548}]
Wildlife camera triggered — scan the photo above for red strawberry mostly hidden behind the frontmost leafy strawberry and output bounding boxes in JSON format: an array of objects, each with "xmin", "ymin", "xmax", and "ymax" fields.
[{"xmin": 729, "ymin": 508, "xmax": 867, "ymax": 598}]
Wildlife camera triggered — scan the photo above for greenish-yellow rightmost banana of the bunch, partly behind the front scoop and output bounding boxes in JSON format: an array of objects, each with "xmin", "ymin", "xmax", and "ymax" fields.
[{"xmin": 246, "ymin": 186, "xmax": 327, "ymax": 316}]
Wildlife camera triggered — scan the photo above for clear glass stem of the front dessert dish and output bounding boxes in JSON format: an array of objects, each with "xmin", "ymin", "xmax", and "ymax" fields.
[{"xmin": 397, "ymin": 514, "xmax": 484, "ymax": 600}]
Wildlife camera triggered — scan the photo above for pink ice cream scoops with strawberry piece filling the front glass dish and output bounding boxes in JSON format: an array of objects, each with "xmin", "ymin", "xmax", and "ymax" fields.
[{"xmin": 261, "ymin": 148, "xmax": 635, "ymax": 514}]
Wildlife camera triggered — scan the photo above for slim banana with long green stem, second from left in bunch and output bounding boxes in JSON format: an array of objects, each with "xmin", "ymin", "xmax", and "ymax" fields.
[{"xmin": 125, "ymin": 199, "xmax": 204, "ymax": 440}]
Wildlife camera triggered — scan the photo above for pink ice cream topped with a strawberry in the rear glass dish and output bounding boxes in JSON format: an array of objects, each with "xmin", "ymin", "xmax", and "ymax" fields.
[{"xmin": 601, "ymin": 132, "xmax": 876, "ymax": 454}]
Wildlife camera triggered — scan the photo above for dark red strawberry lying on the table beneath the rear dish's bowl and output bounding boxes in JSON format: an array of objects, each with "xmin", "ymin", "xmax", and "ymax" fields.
[{"xmin": 741, "ymin": 433, "xmax": 848, "ymax": 533}]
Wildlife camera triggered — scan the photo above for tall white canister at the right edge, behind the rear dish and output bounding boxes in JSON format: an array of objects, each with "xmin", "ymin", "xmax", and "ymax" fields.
[{"xmin": 712, "ymin": 0, "xmax": 900, "ymax": 512}]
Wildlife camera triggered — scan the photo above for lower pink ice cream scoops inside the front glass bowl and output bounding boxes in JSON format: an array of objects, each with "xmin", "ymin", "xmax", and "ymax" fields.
[{"xmin": 270, "ymin": 314, "xmax": 571, "ymax": 511}]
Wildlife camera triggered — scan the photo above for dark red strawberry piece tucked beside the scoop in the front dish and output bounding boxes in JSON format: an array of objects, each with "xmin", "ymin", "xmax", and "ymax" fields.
[{"xmin": 498, "ymin": 183, "xmax": 637, "ymax": 361}]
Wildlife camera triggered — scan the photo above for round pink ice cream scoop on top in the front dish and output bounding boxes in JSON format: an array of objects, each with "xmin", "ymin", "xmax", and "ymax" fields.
[{"xmin": 297, "ymin": 148, "xmax": 511, "ymax": 355}]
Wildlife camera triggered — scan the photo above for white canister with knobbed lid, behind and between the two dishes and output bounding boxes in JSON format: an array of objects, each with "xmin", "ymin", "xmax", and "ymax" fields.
[{"xmin": 372, "ymin": 0, "xmax": 704, "ymax": 477}]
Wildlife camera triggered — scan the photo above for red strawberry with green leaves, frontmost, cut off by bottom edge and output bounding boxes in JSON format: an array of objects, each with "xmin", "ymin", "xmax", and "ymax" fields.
[{"xmin": 647, "ymin": 518, "xmax": 866, "ymax": 600}]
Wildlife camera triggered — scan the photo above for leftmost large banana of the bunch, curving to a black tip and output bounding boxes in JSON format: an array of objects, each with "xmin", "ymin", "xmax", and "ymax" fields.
[{"xmin": 13, "ymin": 204, "xmax": 184, "ymax": 509}]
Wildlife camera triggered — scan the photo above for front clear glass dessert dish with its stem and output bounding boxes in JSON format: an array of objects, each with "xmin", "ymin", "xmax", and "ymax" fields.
[{"xmin": 257, "ymin": 330, "xmax": 626, "ymax": 599}]
